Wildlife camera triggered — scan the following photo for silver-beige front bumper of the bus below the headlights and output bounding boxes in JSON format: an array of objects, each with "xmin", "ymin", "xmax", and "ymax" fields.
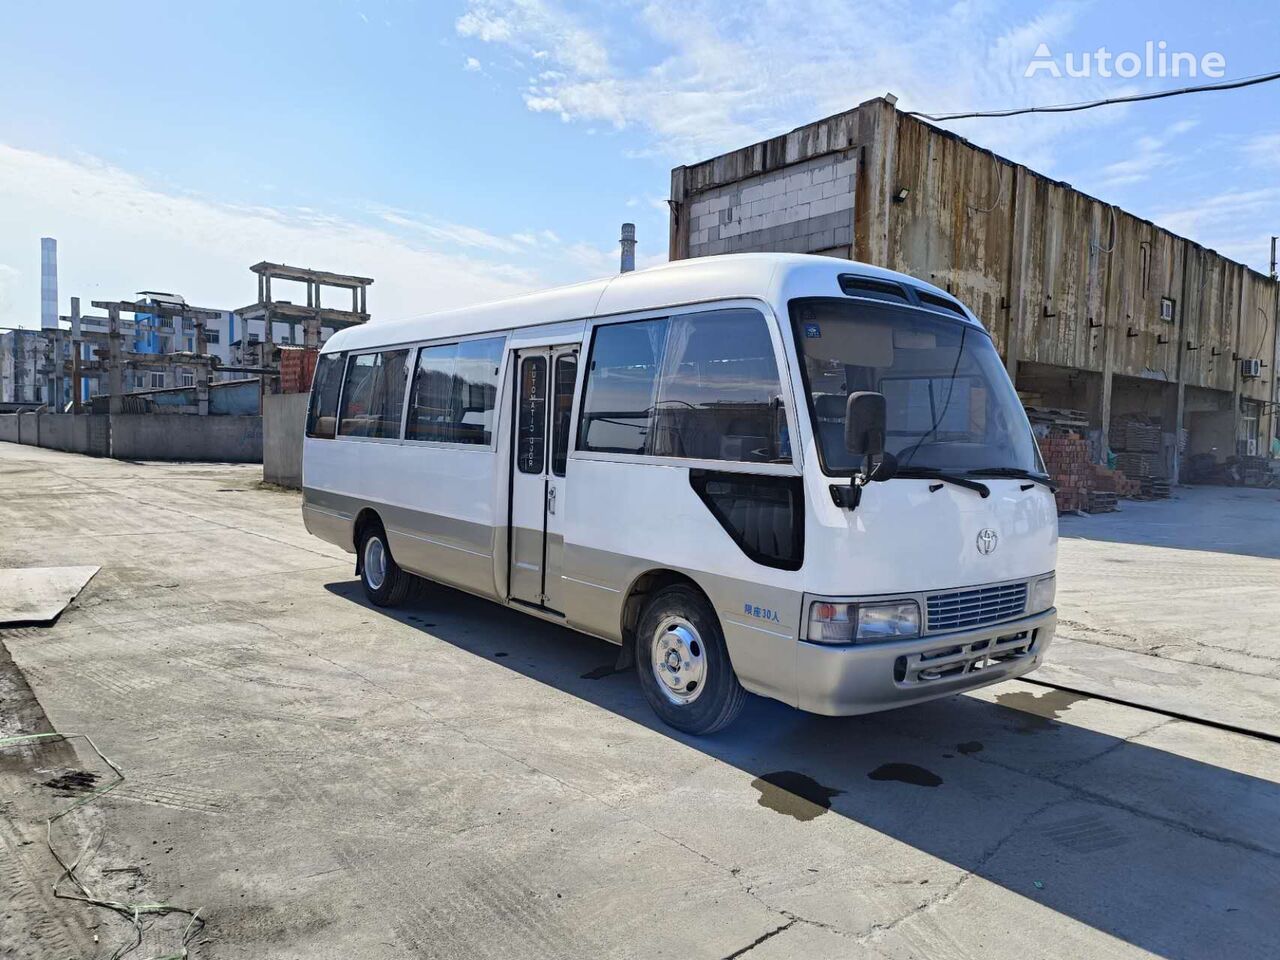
[{"xmin": 796, "ymin": 608, "xmax": 1057, "ymax": 717}]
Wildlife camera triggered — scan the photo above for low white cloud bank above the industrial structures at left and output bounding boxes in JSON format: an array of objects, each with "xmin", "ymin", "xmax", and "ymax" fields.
[{"xmin": 0, "ymin": 145, "xmax": 563, "ymax": 326}]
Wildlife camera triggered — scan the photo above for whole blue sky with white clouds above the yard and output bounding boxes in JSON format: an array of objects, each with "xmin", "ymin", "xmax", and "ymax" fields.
[{"xmin": 0, "ymin": 0, "xmax": 1280, "ymax": 326}]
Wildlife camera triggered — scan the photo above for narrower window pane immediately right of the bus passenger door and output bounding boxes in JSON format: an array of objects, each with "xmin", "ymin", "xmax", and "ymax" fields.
[{"xmin": 579, "ymin": 319, "xmax": 667, "ymax": 453}]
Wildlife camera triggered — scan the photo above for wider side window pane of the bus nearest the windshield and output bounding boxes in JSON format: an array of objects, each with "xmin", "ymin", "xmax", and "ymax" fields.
[{"xmin": 650, "ymin": 310, "xmax": 791, "ymax": 463}]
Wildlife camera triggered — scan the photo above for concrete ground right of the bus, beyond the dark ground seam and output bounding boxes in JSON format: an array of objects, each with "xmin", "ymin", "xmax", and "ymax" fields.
[{"xmin": 1038, "ymin": 486, "xmax": 1280, "ymax": 737}]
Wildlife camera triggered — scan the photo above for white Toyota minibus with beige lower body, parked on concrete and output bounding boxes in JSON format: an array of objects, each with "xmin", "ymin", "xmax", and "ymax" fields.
[{"xmin": 302, "ymin": 253, "xmax": 1057, "ymax": 733}]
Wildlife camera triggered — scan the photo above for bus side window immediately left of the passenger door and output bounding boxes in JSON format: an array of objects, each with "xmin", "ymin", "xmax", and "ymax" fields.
[{"xmin": 406, "ymin": 337, "xmax": 506, "ymax": 445}]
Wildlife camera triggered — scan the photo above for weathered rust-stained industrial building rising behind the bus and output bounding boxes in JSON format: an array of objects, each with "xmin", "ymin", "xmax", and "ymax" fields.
[{"xmin": 669, "ymin": 99, "xmax": 1280, "ymax": 476}]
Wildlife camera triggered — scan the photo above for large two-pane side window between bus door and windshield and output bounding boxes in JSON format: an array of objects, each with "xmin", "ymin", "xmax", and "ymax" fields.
[{"xmin": 579, "ymin": 310, "xmax": 791, "ymax": 462}]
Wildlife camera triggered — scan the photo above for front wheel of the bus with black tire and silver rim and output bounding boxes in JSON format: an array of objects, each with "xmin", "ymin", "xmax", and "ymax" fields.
[{"xmin": 636, "ymin": 584, "xmax": 746, "ymax": 736}]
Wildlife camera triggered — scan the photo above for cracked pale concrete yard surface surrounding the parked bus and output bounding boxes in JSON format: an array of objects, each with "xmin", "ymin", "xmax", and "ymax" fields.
[{"xmin": 0, "ymin": 444, "xmax": 1280, "ymax": 960}]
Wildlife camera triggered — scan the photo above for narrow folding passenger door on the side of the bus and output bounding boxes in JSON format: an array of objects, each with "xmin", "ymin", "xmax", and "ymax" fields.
[{"xmin": 509, "ymin": 347, "xmax": 577, "ymax": 611}]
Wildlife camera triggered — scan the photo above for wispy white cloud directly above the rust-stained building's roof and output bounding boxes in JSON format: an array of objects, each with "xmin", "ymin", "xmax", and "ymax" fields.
[{"xmin": 457, "ymin": 0, "xmax": 1124, "ymax": 168}]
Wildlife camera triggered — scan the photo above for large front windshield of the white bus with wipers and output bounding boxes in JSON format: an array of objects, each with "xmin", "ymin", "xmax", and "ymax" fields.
[{"xmin": 791, "ymin": 300, "xmax": 1043, "ymax": 476}]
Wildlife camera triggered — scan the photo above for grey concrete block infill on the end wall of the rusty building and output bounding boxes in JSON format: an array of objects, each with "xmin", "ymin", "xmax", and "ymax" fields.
[{"xmin": 689, "ymin": 154, "xmax": 858, "ymax": 257}]
